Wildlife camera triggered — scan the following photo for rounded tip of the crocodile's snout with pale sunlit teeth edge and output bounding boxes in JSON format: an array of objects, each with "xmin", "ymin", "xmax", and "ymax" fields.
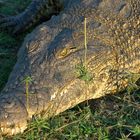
[{"xmin": 0, "ymin": 94, "xmax": 28, "ymax": 135}]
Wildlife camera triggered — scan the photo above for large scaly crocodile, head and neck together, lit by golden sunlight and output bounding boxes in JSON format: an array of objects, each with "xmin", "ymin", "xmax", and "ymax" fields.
[{"xmin": 0, "ymin": 0, "xmax": 140, "ymax": 135}]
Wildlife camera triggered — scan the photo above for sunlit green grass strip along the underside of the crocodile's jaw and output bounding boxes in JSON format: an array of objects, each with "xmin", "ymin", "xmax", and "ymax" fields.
[{"xmin": 3, "ymin": 93, "xmax": 140, "ymax": 140}]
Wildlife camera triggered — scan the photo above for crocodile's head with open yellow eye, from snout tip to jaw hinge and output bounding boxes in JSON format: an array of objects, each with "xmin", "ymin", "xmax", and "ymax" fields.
[{"xmin": 0, "ymin": 25, "xmax": 115, "ymax": 135}]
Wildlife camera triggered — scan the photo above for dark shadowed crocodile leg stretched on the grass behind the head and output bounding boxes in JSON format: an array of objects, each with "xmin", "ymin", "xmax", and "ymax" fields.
[{"xmin": 0, "ymin": 0, "xmax": 63, "ymax": 34}]
